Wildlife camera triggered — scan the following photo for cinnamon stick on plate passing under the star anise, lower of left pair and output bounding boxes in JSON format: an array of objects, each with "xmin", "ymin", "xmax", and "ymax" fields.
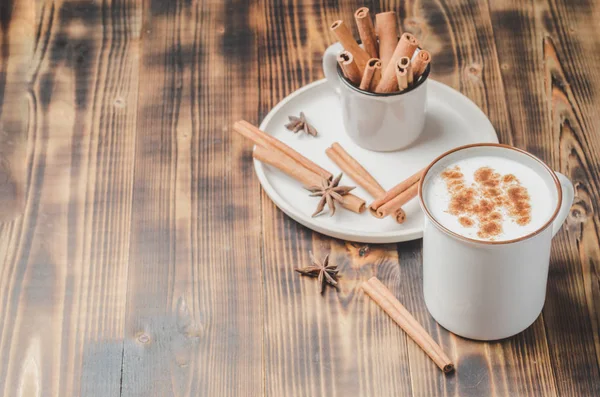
[{"xmin": 252, "ymin": 145, "xmax": 365, "ymax": 214}]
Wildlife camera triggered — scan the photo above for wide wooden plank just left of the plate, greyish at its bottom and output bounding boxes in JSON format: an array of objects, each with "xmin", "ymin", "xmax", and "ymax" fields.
[{"xmin": 122, "ymin": 0, "xmax": 263, "ymax": 396}]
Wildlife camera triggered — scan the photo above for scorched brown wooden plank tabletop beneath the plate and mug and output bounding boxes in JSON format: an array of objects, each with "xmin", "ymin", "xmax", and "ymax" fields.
[{"xmin": 0, "ymin": 0, "xmax": 600, "ymax": 397}]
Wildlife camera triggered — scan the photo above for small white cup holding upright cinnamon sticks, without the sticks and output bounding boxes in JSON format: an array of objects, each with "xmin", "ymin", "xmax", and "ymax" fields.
[{"xmin": 323, "ymin": 43, "xmax": 430, "ymax": 152}]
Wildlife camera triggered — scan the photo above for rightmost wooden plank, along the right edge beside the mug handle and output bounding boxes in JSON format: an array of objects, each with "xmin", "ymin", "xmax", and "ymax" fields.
[{"xmin": 536, "ymin": 1, "xmax": 600, "ymax": 395}]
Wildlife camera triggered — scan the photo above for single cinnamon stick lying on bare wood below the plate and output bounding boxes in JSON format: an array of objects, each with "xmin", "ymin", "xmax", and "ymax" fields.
[{"xmin": 362, "ymin": 277, "xmax": 454, "ymax": 373}]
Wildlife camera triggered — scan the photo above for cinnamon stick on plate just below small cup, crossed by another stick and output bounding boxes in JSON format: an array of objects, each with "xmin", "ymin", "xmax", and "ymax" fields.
[{"xmin": 325, "ymin": 142, "xmax": 406, "ymax": 223}]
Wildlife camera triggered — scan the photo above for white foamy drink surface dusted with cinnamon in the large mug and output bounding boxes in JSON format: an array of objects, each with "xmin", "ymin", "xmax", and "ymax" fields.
[{"xmin": 424, "ymin": 155, "xmax": 556, "ymax": 241}]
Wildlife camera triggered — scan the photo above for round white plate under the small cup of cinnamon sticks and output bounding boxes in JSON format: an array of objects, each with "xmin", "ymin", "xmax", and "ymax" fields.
[{"xmin": 254, "ymin": 79, "xmax": 498, "ymax": 243}]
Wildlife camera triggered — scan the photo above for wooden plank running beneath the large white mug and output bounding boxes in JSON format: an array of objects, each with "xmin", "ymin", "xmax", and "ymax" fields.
[{"xmin": 400, "ymin": 1, "xmax": 556, "ymax": 396}]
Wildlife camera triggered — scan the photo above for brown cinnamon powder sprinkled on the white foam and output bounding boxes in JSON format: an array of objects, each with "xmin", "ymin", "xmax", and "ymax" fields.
[{"xmin": 441, "ymin": 166, "xmax": 531, "ymax": 240}]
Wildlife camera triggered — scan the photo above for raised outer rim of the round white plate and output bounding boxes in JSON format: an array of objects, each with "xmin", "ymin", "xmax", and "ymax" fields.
[{"xmin": 252, "ymin": 78, "xmax": 499, "ymax": 244}]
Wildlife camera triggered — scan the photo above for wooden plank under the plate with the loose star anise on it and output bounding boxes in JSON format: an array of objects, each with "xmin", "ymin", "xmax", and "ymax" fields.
[{"xmin": 255, "ymin": 1, "xmax": 416, "ymax": 396}]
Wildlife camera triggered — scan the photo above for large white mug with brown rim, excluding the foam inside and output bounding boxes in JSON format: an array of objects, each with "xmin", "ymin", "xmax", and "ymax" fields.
[{"xmin": 419, "ymin": 144, "xmax": 575, "ymax": 340}]
